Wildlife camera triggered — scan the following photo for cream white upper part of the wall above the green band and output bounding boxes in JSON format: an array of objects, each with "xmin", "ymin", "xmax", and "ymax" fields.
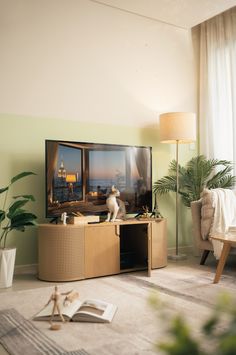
[{"xmin": 0, "ymin": 0, "xmax": 197, "ymax": 126}]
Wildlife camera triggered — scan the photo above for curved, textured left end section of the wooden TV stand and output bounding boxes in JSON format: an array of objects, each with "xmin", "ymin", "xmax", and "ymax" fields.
[{"xmin": 38, "ymin": 225, "xmax": 84, "ymax": 281}]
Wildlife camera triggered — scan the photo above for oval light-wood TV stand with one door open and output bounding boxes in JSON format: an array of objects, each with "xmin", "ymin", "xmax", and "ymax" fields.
[{"xmin": 38, "ymin": 218, "xmax": 167, "ymax": 282}]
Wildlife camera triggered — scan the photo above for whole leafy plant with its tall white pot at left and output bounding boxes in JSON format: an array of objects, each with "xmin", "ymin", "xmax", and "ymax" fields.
[{"xmin": 0, "ymin": 172, "xmax": 37, "ymax": 288}]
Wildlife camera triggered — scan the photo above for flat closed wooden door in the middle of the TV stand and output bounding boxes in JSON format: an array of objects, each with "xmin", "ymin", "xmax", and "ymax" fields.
[{"xmin": 85, "ymin": 225, "xmax": 120, "ymax": 278}]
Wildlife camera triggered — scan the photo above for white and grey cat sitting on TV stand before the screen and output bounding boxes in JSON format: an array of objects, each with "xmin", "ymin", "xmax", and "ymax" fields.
[{"xmin": 106, "ymin": 185, "xmax": 125, "ymax": 222}]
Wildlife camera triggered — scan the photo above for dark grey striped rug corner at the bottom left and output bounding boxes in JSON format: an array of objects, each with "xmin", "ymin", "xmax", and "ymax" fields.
[{"xmin": 0, "ymin": 308, "xmax": 89, "ymax": 355}]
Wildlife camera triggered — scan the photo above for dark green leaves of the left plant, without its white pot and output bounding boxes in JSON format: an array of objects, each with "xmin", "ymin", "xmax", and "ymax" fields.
[{"xmin": 0, "ymin": 172, "xmax": 37, "ymax": 248}]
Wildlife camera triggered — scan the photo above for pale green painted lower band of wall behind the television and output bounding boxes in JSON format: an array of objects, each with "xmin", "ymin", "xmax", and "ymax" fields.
[{"xmin": 0, "ymin": 114, "xmax": 195, "ymax": 265}]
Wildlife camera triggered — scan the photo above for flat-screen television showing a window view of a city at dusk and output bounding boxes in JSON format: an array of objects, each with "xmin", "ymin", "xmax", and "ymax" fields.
[{"xmin": 45, "ymin": 140, "xmax": 152, "ymax": 218}]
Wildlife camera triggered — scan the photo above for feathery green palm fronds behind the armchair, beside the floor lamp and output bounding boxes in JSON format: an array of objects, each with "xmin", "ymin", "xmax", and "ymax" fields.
[{"xmin": 153, "ymin": 155, "xmax": 236, "ymax": 207}]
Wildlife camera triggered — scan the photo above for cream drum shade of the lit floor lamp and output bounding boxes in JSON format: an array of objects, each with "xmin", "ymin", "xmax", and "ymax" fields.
[{"xmin": 160, "ymin": 112, "xmax": 196, "ymax": 143}]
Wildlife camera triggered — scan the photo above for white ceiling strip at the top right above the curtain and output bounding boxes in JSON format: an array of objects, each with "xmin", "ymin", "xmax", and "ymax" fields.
[{"xmin": 92, "ymin": 0, "xmax": 236, "ymax": 29}]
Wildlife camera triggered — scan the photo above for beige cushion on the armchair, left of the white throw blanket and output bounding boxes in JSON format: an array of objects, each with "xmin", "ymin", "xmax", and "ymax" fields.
[{"xmin": 201, "ymin": 189, "xmax": 215, "ymax": 240}]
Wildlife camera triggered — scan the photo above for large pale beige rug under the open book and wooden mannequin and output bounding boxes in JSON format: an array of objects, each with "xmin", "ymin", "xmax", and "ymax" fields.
[{"xmin": 0, "ymin": 268, "xmax": 221, "ymax": 355}]
